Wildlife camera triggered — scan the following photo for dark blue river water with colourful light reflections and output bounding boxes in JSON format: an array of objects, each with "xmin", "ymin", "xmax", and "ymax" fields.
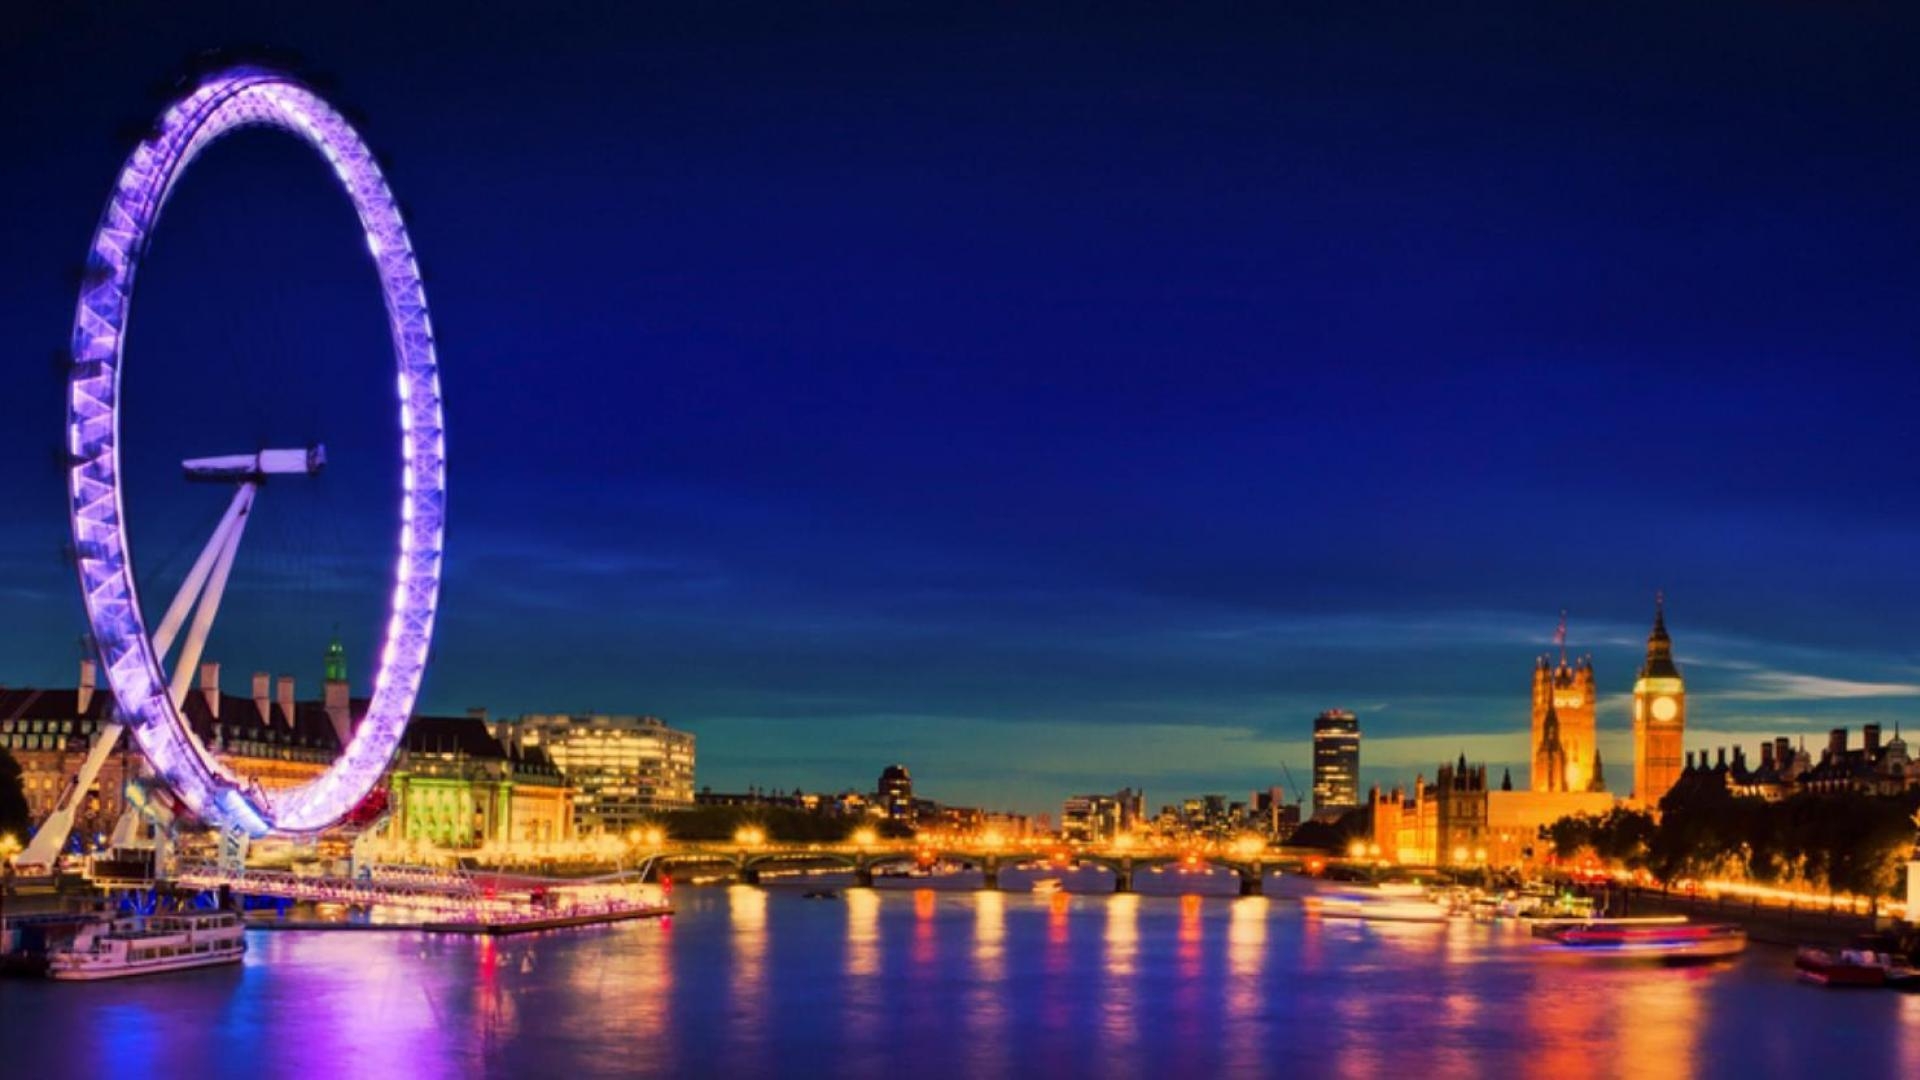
[{"xmin": 0, "ymin": 880, "xmax": 1920, "ymax": 1080}]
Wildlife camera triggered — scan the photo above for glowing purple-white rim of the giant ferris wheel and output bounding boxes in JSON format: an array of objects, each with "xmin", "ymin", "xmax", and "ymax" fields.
[{"xmin": 67, "ymin": 67, "xmax": 445, "ymax": 836}]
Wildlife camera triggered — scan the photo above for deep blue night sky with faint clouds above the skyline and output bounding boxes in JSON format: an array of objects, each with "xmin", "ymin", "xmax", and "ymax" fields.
[{"xmin": 0, "ymin": 2, "xmax": 1920, "ymax": 809}]
